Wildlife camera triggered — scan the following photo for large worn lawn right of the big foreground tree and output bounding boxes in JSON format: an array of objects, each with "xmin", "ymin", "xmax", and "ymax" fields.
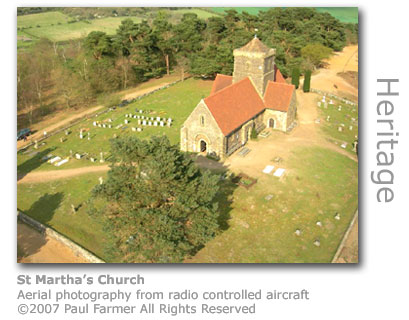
[{"xmin": 188, "ymin": 147, "xmax": 358, "ymax": 263}]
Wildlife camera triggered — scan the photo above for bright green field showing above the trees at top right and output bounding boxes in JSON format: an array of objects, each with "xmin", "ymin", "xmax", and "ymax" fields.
[{"xmin": 212, "ymin": 7, "xmax": 358, "ymax": 23}]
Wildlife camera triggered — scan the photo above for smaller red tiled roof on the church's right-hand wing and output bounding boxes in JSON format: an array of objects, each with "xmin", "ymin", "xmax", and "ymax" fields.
[{"xmin": 264, "ymin": 81, "xmax": 295, "ymax": 112}]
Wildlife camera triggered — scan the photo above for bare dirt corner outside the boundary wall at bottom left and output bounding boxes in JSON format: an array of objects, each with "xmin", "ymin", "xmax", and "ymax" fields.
[{"xmin": 17, "ymin": 222, "xmax": 88, "ymax": 263}]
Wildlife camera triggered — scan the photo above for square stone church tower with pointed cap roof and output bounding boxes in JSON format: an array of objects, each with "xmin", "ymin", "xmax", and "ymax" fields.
[{"xmin": 233, "ymin": 36, "xmax": 276, "ymax": 97}]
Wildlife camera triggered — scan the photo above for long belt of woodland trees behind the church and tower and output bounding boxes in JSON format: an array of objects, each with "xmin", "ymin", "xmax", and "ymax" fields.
[{"xmin": 17, "ymin": 8, "xmax": 358, "ymax": 127}]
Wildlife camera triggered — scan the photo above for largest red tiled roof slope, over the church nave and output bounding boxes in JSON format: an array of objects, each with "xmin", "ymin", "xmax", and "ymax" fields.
[{"xmin": 204, "ymin": 77, "xmax": 265, "ymax": 136}]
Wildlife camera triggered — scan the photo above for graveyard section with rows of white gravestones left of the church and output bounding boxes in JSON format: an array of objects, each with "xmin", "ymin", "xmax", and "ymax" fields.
[{"xmin": 17, "ymin": 79, "xmax": 211, "ymax": 174}]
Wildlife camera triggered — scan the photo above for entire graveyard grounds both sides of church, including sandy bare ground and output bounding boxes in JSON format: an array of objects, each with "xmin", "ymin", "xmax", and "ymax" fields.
[{"xmin": 17, "ymin": 37, "xmax": 358, "ymax": 263}]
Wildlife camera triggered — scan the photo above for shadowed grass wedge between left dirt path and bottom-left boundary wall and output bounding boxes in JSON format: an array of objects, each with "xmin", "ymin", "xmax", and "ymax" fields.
[{"xmin": 17, "ymin": 173, "xmax": 106, "ymax": 258}]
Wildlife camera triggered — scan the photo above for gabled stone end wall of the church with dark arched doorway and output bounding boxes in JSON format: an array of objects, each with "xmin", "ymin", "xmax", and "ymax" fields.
[{"xmin": 180, "ymin": 100, "xmax": 224, "ymax": 156}]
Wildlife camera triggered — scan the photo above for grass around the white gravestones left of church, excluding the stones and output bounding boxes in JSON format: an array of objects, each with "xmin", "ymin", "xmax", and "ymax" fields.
[{"xmin": 17, "ymin": 79, "xmax": 212, "ymax": 173}]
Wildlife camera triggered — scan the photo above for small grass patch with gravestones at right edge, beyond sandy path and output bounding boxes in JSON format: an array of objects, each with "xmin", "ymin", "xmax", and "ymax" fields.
[{"xmin": 317, "ymin": 97, "xmax": 358, "ymax": 153}]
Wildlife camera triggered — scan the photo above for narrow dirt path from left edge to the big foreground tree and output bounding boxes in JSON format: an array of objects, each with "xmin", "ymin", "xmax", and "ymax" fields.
[{"xmin": 17, "ymin": 165, "xmax": 109, "ymax": 184}]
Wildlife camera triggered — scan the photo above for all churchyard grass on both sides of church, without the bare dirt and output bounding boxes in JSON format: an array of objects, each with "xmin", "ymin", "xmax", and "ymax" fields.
[{"xmin": 17, "ymin": 79, "xmax": 358, "ymax": 263}]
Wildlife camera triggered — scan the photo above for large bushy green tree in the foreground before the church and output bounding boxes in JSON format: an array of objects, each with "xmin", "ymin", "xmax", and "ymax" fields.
[{"xmin": 90, "ymin": 136, "xmax": 219, "ymax": 263}]
